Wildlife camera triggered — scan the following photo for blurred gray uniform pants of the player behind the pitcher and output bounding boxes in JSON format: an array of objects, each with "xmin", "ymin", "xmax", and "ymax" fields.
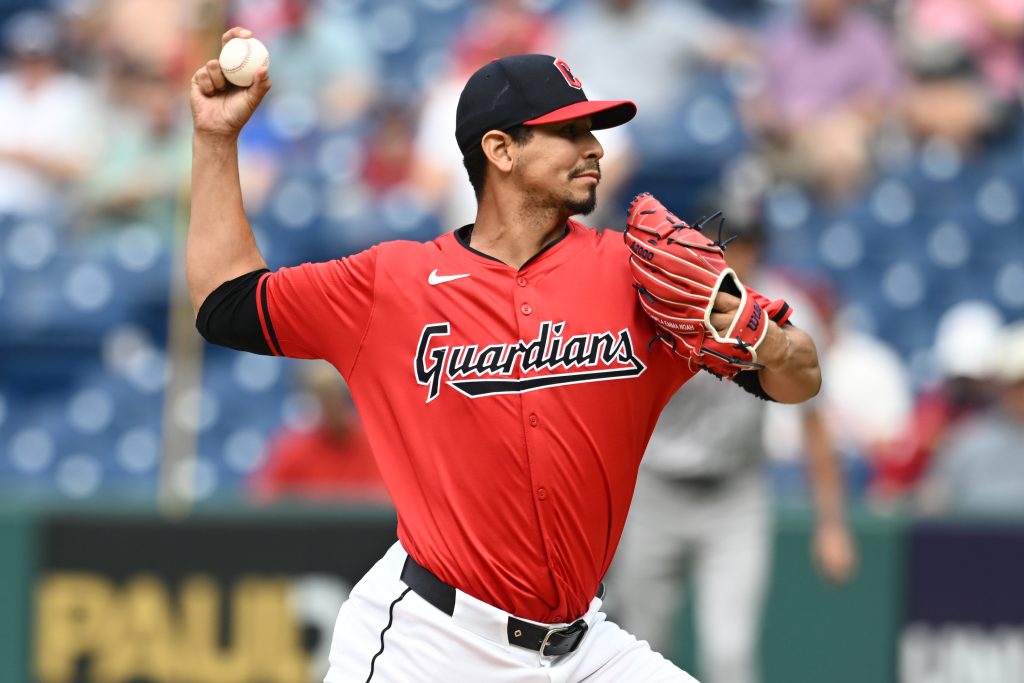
[{"xmin": 609, "ymin": 468, "xmax": 772, "ymax": 683}]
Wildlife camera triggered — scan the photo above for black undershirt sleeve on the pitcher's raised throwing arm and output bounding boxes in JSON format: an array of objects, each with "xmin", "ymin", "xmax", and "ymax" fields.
[{"xmin": 196, "ymin": 268, "xmax": 274, "ymax": 355}]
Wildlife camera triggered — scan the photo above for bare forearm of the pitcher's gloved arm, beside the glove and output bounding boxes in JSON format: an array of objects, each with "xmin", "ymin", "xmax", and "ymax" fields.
[{"xmin": 758, "ymin": 322, "xmax": 821, "ymax": 403}]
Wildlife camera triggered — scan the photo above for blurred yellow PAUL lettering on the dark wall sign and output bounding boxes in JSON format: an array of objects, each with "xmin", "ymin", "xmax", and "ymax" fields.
[{"xmin": 35, "ymin": 571, "xmax": 319, "ymax": 683}]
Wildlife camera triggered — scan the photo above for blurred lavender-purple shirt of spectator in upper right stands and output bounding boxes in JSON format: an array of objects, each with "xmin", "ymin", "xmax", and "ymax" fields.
[{"xmin": 764, "ymin": 10, "xmax": 901, "ymax": 126}]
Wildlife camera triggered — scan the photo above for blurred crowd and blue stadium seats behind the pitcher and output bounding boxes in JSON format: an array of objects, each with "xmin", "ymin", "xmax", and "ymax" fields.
[{"xmin": 0, "ymin": 0, "xmax": 1024, "ymax": 513}]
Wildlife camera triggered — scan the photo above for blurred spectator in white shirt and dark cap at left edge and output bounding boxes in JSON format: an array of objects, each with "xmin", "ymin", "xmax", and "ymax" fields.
[{"xmin": 0, "ymin": 10, "xmax": 95, "ymax": 216}]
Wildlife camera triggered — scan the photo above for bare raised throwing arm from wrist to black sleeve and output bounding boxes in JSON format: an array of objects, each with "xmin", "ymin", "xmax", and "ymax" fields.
[{"xmin": 185, "ymin": 133, "xmax": 266, "ymax": 311}]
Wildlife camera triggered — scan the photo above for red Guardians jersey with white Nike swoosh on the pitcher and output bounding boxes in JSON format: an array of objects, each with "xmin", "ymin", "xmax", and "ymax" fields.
[{"xmin": 257, "ymin": 221, "xmax": 692, "ymax": 622}]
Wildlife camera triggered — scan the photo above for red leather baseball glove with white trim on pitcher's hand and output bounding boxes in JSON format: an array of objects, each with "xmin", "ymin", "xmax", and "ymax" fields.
[{"xmin": 623, "ymin": 193, "xmax": 792, "ymax": 378}]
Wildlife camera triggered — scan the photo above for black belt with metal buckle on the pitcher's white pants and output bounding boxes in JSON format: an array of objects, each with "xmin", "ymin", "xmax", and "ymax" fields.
[{"xmin": 401, "ymin": 557, "xmax": 604, "ymax": 656}]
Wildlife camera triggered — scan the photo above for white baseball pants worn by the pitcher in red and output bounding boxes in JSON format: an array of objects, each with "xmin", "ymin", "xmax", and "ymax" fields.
[{"xmin": 324, "ymin": 543, "xmax": 696, "ymax": 683}]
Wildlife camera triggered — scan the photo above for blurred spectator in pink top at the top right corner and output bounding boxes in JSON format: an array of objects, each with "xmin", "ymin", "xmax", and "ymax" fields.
[{"xmin": 900, "ymin": 0, "xmax": 1024, "ymax": 146}]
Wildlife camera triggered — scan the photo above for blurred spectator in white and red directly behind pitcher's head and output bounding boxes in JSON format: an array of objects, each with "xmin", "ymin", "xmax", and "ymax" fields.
[{"xmin": 414, "ymin": 0, "xmax": 632, "ymax": 229}]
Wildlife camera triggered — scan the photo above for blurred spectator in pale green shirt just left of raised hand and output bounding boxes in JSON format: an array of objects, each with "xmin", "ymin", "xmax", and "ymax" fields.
[{"xmin": 79, "ymin": 57, "xmax": 191, "ymax": 234}]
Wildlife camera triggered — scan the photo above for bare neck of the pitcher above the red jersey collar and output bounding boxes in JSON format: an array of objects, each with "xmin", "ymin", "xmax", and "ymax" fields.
[{"xmin": 469, "ymin": 196, "xmax": 569, "ymax": 269}]
